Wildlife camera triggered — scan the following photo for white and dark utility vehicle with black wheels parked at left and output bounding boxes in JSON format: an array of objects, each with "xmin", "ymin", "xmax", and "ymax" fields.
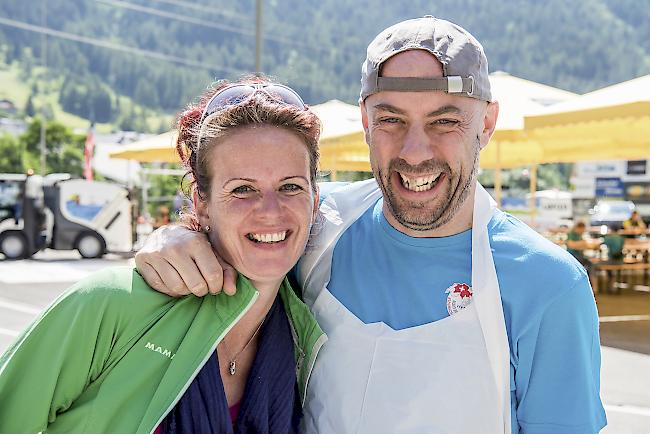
[{"xmin": 0, "ymin": 174, "xmax": 133, "ymax": 259}]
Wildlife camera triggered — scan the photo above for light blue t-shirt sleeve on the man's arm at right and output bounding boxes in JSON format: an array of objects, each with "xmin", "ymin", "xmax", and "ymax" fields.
[{"xmin": 515, "ymin": 276, "xmax": 607, "ymax": 434}]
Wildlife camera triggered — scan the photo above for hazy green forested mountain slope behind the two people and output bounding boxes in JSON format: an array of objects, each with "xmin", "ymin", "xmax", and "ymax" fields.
[{"xmin": 0, "ymin": 0, "xmax": 650, "ymax": 122}]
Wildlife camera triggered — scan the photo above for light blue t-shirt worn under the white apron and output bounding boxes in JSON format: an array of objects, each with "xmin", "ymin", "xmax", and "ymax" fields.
[{"xmin": 321, "ymin": 189, "xmax": 606, "ymax": 434}]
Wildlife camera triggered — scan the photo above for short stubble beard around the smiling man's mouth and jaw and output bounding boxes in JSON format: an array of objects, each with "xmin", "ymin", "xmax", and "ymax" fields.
[{"xmin": 375, "ymin": 135, "xmax": 481, "ymax": 231}]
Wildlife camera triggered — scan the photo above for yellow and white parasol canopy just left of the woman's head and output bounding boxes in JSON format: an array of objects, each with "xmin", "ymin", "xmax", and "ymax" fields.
[{"xmin": 108, "ymin": 130, "xmax": 180, "ymax": 163}]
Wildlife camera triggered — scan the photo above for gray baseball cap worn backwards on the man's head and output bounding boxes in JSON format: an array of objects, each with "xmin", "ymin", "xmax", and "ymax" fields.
[{"xmin": 361, "ymin": 15, "xmax": 492, "ymax": 101}]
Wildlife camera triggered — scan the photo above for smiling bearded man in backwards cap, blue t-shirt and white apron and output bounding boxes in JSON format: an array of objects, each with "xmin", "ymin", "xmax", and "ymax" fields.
[{"xmin": 136, "ymin": 16, "xmax": 606, "ymax": 434}]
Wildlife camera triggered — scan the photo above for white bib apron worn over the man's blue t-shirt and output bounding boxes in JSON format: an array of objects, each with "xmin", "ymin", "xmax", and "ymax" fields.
[{"xmin": 298, "ymin": 180, "xmax": 511, "ymax": 434}]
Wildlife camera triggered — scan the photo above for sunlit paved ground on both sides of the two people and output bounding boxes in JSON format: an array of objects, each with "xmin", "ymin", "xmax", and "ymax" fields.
[{"xmin": 0, "ymin": 251, "xmax": 650, "ymax": 434}]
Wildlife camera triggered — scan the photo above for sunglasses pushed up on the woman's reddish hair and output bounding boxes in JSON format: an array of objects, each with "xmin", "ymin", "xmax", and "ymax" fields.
[{"xmin": 201, "ymin": 83, "xmax": 307, "ymax": 122}]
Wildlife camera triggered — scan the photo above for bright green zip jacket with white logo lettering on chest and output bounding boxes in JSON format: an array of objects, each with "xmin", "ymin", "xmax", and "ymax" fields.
[{"xmin": 0, "ymin": 268, "xmax": 327, "ymax": 434}]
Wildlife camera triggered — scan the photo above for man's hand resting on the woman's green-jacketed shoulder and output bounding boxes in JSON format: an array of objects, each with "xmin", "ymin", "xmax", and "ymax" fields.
[{"xmin": 135, "ymin": 225, "xmax": 237, "ymax": 297}]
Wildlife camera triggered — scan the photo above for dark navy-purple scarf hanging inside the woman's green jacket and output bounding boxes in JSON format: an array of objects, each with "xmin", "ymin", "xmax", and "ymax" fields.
[{"xmin": 161, "ymin": 296, "xmax": 302, "ymax": 434}]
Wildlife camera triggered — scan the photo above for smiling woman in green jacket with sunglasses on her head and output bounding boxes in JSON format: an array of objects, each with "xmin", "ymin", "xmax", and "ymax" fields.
[{"xmin": 0, "ymin": 78, "xmax": 326, "ymax": 434}]
